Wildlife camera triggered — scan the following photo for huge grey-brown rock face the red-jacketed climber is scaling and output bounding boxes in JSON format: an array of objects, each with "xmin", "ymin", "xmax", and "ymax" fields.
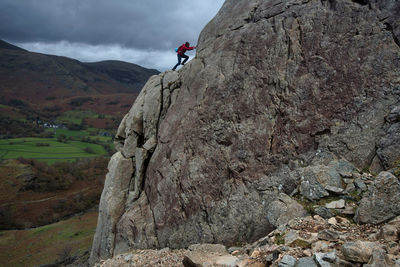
[{"xmin": 91, "ymin": 0, "xmax": 400, "ymax": 263}]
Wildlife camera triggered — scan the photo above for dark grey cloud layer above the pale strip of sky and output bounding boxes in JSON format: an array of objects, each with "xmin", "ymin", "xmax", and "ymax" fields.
[{"xmin": 0, "ymin": 0, "xmax": 223, "ymax": 51}]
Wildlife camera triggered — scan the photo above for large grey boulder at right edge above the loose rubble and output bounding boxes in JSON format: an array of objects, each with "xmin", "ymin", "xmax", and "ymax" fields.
[{"xmin": 354, "ymin": 172, "xmax": 400, "ymax": 224}]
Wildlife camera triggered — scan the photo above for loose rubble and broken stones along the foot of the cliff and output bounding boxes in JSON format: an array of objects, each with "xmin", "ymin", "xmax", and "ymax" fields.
[{"xmin": 96, "ymin": 215, "xmax": 400, "ymax": 267}]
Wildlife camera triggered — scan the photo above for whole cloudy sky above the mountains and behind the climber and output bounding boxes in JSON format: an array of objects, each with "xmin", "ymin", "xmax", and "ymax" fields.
[{"xmin": 0, "ymin": 0, "xmax": 224, "ymax": 71}]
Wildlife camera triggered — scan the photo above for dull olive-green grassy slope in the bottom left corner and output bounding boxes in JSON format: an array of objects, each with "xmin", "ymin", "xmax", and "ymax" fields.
[{"xmin": 0, "ymin": 212, "xmax": 98, "ymax": 267}]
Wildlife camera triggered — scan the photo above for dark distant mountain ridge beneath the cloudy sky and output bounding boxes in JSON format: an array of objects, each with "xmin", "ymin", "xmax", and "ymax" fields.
[{"xmin": 0, "ymin": 40, "xmax": 159, "ymax": 112}]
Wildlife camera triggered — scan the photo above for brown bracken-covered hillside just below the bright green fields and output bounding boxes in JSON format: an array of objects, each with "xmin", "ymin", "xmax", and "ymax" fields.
[{"xmin": 0, "ymin": 157, "xmax": 107, "ymax": 231}]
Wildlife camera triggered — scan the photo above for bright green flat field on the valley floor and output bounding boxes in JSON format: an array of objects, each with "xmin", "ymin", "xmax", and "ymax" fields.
[{"xmin": 0, "ymin": 137, "xmax": 107, "ymax": 164}]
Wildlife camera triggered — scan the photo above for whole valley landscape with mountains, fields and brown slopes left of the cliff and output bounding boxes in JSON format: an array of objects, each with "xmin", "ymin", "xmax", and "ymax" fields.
[{"xmin": 0, "ymin": 40, "xmax": 158, "ymax": 266}]
